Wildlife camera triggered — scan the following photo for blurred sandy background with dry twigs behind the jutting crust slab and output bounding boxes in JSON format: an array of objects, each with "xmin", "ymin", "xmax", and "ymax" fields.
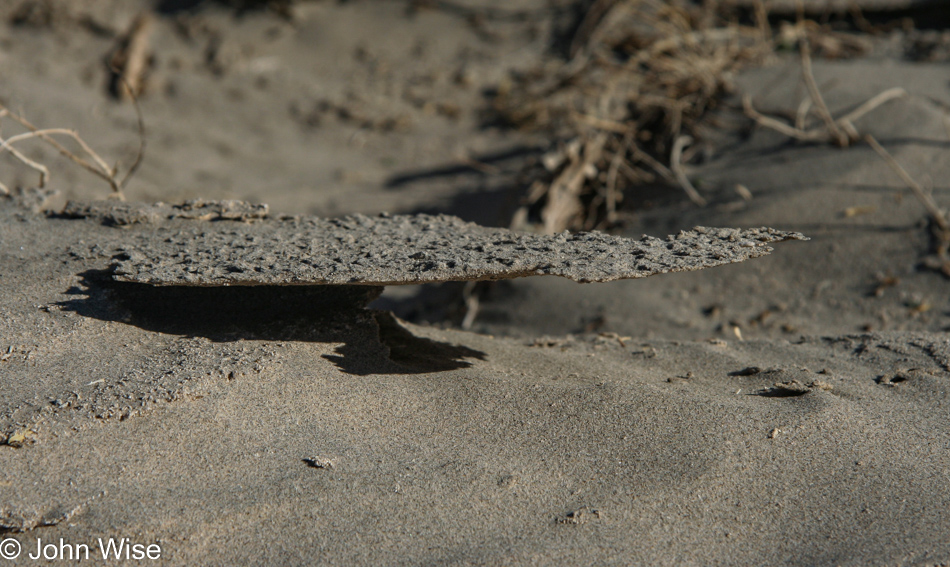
[{"xmin": 0, "ymin": 0, "xmax": 950, "ymax": 340}]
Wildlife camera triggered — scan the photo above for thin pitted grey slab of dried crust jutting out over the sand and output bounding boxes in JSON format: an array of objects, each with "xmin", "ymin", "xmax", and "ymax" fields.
[{"xmin": 98, "ymin": 202, "xmax": 805, "ymax": 286}]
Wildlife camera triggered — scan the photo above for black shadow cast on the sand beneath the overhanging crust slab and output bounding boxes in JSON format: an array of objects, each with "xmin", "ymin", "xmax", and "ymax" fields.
[{"xmin": 58, "ymin": 270, "xmax": 485, "ymax": 375}]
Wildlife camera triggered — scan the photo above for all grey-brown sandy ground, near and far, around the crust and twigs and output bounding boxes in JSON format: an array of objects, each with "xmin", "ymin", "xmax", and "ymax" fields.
[{"xmin": 0, "ymin": 1, "xmax": 950, "ymax": 566}]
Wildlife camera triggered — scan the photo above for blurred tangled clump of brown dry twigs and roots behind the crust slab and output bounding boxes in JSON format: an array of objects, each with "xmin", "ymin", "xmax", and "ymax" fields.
[{"xmin": 493, "ymin": 0, "xmax": 772, "ymax": 232}]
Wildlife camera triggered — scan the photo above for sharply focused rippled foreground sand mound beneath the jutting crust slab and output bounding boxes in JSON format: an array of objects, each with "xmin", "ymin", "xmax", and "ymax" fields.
[{"xmin": 0, "ymin": 203, "xmax": 950, "ymax": 565}]
